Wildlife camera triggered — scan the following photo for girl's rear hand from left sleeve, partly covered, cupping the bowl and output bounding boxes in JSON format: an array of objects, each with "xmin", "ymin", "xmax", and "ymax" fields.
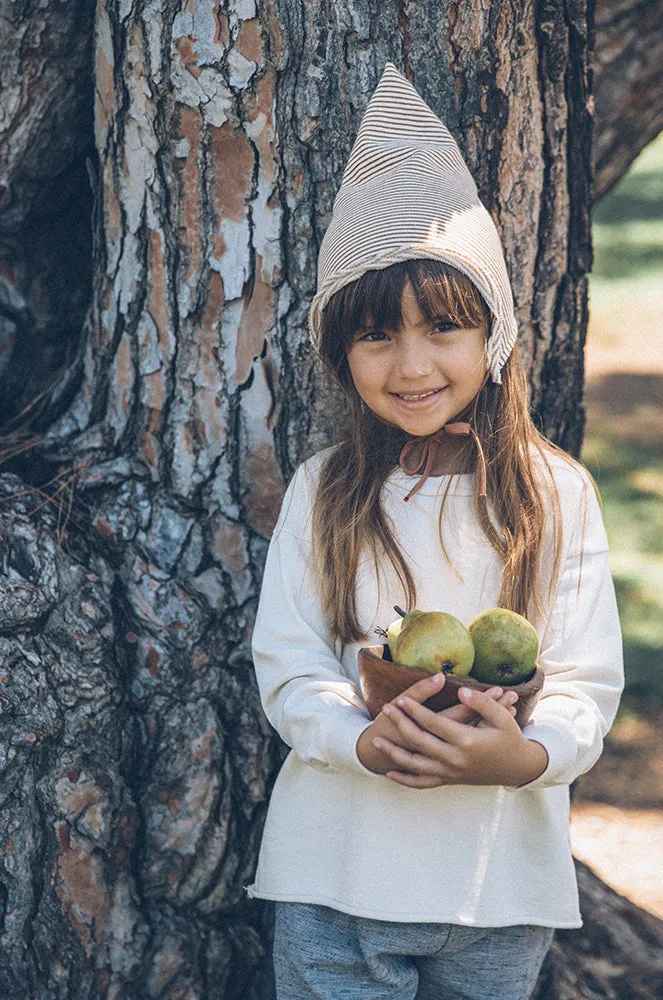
[{"xmin": 357, "ymin": 673, "xmax": 516, "ymax": 774}]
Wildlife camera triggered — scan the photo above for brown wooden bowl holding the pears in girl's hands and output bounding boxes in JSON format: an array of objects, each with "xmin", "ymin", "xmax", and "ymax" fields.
[{"xmin": 359, "ymin": 645, "xmax": 545, "ymax": 729}]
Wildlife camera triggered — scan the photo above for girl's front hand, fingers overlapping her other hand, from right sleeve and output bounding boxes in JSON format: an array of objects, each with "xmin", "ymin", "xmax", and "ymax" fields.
[{"xmin": 374, "ymin": 688, "xmax": 548, "ymax": 788}]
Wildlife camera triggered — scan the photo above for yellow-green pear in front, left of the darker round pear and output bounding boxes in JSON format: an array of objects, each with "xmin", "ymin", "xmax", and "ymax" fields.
[{"xmin": 392, "ymin": 611, "xmax": 474, "ymax": 677}]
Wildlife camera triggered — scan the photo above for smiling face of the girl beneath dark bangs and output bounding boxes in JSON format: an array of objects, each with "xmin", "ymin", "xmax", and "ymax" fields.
[{"xmin": 347, "ymin": 281, "xmax": 486, "ymax": 437}]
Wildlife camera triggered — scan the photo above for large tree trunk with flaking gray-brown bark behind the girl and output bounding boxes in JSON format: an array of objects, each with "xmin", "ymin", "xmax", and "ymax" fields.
[{"xmin": 0, "ymin": 0, "xmax": 660, "ymax": 1000}]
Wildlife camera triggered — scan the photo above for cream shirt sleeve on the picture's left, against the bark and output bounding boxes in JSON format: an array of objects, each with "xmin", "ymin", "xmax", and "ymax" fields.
[{"xmin": 252, "ymin": 465, "xmax": 379, "ymax": 777}]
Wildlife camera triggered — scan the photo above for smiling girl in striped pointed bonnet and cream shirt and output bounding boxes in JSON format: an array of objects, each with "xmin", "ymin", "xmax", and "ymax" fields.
[{"xmin": 249, "ymin": 65, "xmax": 622, "ymax": 1000}]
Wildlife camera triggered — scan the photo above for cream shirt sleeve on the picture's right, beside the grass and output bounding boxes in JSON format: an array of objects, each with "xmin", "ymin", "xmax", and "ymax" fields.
[{"xmin": 521, "ymin": 471, "xmax": 624, "ymax": 790}]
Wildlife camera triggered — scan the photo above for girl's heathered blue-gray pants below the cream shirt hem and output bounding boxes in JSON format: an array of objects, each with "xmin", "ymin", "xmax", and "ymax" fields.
[{"xmin": 274, "ymin": 903, "xmax": 553, "ymax": 1000}]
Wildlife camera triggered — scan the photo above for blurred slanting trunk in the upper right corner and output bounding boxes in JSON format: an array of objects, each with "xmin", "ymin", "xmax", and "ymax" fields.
[{"xmin": 594, "ymin": 0, "xmax": 663, "ymax": 201}]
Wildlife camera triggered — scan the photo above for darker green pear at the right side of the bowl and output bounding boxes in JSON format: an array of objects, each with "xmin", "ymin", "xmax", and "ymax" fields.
[{"xmin": 468, "ymin": 608, "xmax": 539, "ymax": 684}]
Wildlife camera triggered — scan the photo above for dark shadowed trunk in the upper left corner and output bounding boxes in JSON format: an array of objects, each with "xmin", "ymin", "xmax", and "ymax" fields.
[{"xmin": 0, "ymin": 0, "xmax": 95, "ymax": 425}]
